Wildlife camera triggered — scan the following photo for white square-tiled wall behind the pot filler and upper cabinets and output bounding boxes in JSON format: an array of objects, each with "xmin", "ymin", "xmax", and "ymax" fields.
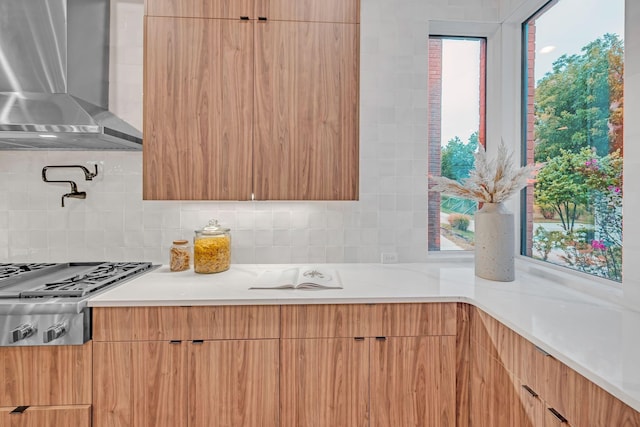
[{"xmin": 0, "ymin": 0, "xmax": 499, "ymax": 263}]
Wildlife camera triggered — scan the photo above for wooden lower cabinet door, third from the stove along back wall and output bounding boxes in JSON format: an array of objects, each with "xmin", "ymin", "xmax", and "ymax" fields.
[{"xmin": 280, "ymin": 338, "xmax": 369, "ymax": 427}]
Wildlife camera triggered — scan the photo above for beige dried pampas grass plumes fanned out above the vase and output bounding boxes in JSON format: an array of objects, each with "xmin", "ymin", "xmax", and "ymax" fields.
[{"xmin": 429, "ymin": 142, "xmax": 535, "ymax": 203}]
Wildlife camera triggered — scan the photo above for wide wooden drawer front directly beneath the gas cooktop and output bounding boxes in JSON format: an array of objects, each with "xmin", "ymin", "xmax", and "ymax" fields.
[{"xmin": 0, "ymin": 342, "xmax": 92, "ymax": 408}]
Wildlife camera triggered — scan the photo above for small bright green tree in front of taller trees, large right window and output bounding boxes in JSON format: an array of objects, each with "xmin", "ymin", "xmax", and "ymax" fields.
[{"xmin": 534, "ymin": 147, "xmax": 594, "ymax": 233}]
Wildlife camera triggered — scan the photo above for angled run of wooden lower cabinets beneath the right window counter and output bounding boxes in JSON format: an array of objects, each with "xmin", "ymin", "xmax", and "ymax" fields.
[{"xmin": 469, "ymin": 308, "xmax": 640, "ymax": 427}]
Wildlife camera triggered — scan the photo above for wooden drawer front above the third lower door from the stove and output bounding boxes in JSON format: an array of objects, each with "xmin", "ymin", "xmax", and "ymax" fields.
[{"xmin": 281, "ymin": 304, "xmax": 370, "ymax": 338}]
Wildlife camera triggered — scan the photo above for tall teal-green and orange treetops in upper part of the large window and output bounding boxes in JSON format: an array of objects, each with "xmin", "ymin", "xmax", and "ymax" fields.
[{"xmin": 535, "ymin": 34, "xmax": 624, "ymax": 161}]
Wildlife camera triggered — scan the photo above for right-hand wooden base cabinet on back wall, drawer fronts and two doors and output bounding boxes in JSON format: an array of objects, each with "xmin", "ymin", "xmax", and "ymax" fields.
[{"xmin": 280, "ymin": 303, "xmax": 456, "ymax": 427}]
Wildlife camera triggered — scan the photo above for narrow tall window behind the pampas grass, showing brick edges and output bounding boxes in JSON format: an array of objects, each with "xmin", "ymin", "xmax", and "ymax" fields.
[{"xmin": 428, "ymin": 36, "xmax": 486, "ymax": 251}]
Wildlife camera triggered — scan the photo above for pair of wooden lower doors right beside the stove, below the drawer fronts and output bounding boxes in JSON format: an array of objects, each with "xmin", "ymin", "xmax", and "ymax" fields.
[{"xmin": 93, "ymin": 339, "xmax": 279, "ymax": 427}]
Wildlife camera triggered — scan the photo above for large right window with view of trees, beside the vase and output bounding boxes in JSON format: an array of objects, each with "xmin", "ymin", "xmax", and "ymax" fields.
[{"xmin": 522, "ymin": 0, "xmax": 624, "ymax": 282}]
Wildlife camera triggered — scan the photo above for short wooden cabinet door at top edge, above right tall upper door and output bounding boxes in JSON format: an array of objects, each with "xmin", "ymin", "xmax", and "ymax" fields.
[{"xmin": 258, "ymin": 0, "xmax": 360, "ymax": 24}]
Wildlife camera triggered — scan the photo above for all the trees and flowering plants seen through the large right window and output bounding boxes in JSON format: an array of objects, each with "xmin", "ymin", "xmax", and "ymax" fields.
[{"xmin": 532, "ymin": 34, "xmax": 624, "ymax": 281}]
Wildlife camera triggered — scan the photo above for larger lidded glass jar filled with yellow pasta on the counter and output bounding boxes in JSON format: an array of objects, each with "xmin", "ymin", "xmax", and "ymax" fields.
[{"xmin": 193, "ymin": 219, "xmax": 231, "ymax": 273}]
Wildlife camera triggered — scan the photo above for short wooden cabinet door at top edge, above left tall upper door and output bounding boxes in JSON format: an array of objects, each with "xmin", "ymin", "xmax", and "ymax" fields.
[{"xmin": 145, "ymin": 0, "xmax": 254, "ymax": 19}]
